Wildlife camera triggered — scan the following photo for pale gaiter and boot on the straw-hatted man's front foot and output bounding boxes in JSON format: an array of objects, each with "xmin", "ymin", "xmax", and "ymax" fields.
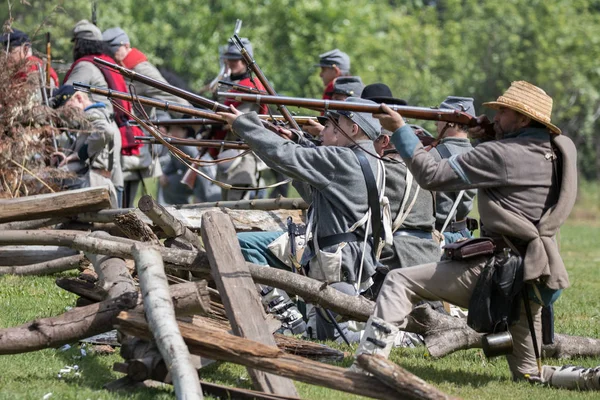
[{"xmin": 350, "ymin": 316, "xmax": 399, "ymax": 373}]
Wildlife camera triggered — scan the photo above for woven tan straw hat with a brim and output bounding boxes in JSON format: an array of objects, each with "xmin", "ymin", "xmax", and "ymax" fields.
[{"xmin": 483, "ymin": 81, "xmax": 561, "ymax": 134}]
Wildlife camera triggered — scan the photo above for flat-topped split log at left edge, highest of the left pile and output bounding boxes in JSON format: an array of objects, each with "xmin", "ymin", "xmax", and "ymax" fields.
[{"xmin": 0, "ymin": 187, "xmax": 110, "ymax": 222}]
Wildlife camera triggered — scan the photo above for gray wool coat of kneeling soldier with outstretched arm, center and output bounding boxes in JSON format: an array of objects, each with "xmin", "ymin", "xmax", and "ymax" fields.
[{"xmin": 233, "ymin": 112, "xmax": 377, "ymax": 283}]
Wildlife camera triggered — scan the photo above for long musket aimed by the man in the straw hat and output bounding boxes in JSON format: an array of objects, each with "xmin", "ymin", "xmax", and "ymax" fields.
[{"xmin": 218, "ymin": 92, "xmax": 490, "ymax": 126}]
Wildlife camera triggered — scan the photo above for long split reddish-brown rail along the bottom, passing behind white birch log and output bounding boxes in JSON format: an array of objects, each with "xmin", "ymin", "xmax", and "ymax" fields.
[{"xmin": 117, "ymin": 312, "xmax": 410, "ymax": 400}]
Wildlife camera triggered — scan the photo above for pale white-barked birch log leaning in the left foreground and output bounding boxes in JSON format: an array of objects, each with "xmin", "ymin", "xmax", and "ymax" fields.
[{"xmin": 132, "ymin": 244, "xmax": 203, "ymax": 399}]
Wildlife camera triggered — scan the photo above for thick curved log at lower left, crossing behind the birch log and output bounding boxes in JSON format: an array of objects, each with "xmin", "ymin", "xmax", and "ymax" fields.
[{"xmin": 0, "ymin": 281, "xmax": 209, "ymax": 355}]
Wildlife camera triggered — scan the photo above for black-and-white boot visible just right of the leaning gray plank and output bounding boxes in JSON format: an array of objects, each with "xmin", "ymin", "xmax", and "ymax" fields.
[{"xmin": 260, "ymin": 286, "xmax": 306, "ymax": 335}]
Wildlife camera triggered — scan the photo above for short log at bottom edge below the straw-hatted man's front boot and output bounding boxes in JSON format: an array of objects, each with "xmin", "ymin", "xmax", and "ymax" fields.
[{"xmin": 356, "ymin": 354, "xmax": 452, "ymax": 400}]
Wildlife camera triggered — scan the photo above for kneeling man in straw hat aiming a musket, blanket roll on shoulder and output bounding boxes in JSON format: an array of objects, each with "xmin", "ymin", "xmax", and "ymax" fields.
[{"xmin": 357, "ymin": 81, "xmax": 577, "ymax": 379}]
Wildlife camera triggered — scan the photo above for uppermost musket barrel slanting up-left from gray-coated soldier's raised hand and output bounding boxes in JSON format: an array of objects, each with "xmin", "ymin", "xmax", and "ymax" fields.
[{"xmin": 94, "ymin": 57, "xmax": 230, "ymax": 112}]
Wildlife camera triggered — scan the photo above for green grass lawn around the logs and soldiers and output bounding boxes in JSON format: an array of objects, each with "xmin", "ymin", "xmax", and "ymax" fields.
[{"xmin": 0, "ymin": 184, "xmax": 600, "ymax": 400}]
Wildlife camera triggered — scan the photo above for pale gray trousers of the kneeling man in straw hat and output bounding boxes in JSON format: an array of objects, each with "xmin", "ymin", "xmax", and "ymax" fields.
[{"xmin": 374, "ymin": 257, "xmax": 542, "ymax": 379}]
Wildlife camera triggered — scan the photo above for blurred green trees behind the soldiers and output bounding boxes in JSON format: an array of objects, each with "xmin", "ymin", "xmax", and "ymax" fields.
[{"xmin": 0, "ymin": 0, "xmax": 600, "ymax": 180}]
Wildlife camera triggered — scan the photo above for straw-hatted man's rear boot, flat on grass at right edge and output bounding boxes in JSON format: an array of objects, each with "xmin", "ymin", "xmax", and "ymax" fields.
[{"xmin": 542, "ymin": 365, "xmax": 600, "ymax": 390}]
